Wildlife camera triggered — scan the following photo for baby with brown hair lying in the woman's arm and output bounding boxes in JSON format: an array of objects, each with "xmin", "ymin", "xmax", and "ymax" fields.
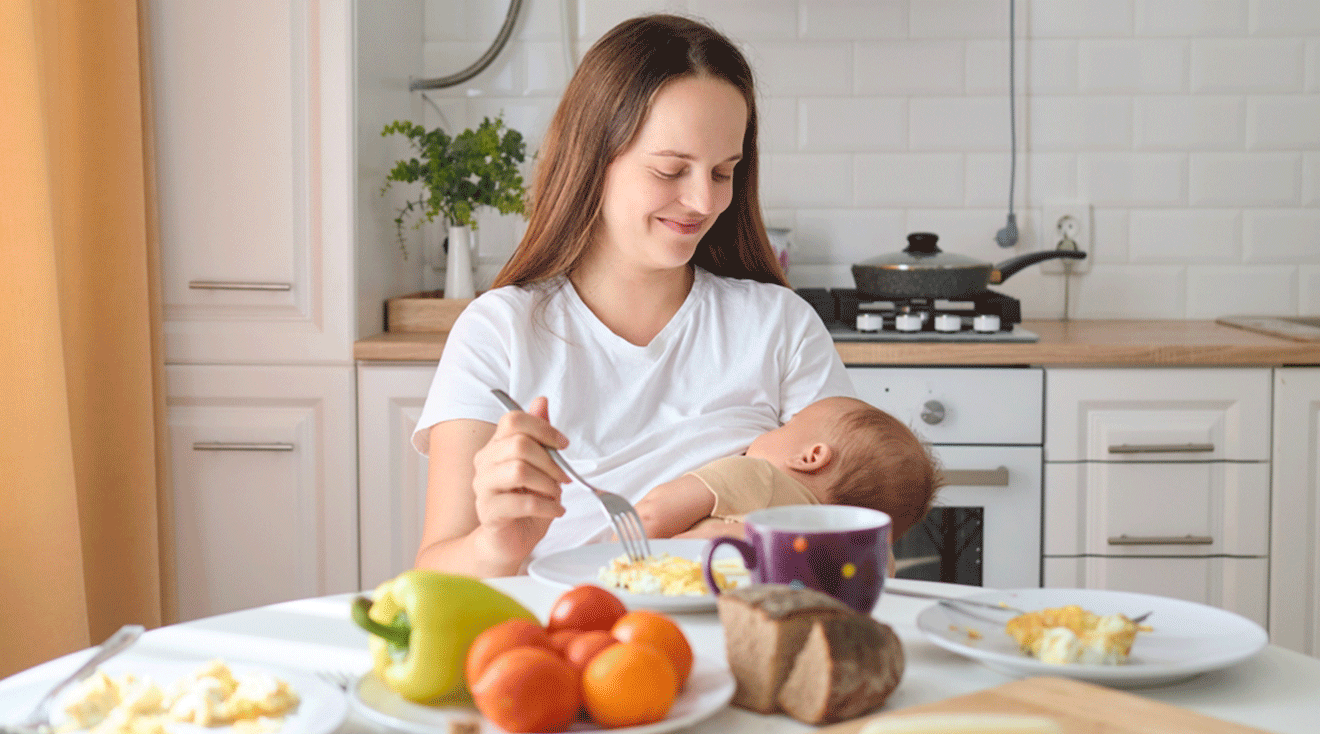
[{"xmin": 636, "ymin": 397, "xmax": 940, "ymax": 540}]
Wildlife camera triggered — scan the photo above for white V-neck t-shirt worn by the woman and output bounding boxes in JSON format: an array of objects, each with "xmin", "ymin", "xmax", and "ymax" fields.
[{"xmin": 413, "ymin": 268, "xmax": 854, "ymax": 558}]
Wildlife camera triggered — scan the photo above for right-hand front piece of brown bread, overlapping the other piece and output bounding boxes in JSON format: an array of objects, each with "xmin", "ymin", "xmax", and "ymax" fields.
[{"xmin": 779, "ymin": 614, "xmax": 904, "ymax": 725}]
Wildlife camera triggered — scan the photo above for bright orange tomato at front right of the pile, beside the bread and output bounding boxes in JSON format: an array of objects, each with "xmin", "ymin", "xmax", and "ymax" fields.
[{"xmin": 582, "ymin": 643, "xmax": 678, "ymax": 727}]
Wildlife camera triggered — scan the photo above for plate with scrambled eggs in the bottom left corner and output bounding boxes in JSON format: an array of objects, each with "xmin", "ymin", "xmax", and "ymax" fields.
[{"xmin": 0, "ymin": 656, "xmax": 348, "ymax": 734}]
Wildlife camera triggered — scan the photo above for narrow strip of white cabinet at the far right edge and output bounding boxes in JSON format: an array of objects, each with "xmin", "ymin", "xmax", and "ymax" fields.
[{"xmin": 1270, "ymin": 367, "xmax": 1320, "ymax": 656}]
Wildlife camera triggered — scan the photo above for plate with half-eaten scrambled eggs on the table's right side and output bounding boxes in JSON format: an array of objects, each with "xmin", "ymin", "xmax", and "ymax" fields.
[{"xmin": 917, "ymin": 589, "xmax": 1269, "ymax": 688}]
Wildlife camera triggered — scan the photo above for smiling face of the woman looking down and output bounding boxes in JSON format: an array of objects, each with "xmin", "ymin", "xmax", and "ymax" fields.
[{"xmin": 593, "ymin": 77, "xmax": 747, "ymax": 272}]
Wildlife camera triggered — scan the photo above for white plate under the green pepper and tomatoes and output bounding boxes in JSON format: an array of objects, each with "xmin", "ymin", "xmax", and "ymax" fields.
[{"xmin": 348, "ymin": 656, "xmax": 734, "ymax": 734}]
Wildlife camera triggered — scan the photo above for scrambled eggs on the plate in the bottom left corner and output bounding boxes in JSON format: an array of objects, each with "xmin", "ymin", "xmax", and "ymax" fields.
[{"xmin": 61, "ymin": 660, "xmax": 298, "ymax": 734}]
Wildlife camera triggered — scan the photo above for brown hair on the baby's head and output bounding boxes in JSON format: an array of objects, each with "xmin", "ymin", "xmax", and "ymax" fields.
[{"xmin": 829, "ymin": 404, "xmax": 944, "ymax": 540}]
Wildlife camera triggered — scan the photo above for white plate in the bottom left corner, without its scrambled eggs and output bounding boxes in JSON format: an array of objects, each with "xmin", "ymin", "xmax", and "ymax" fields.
[{"xmin": 0, "ymin": 657, "xmax": 348, "ymax": 734}]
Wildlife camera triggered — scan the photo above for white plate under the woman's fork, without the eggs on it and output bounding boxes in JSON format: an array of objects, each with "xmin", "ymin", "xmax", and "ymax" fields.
[{"xmin": 527, "ymin": 539, "xmax": 747, "ymax": 611}]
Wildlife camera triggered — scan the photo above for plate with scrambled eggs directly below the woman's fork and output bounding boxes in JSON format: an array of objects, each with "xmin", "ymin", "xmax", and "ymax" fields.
[{"xmin": 527, "ymin": 539, "xmax": 748, "ymax": 611}]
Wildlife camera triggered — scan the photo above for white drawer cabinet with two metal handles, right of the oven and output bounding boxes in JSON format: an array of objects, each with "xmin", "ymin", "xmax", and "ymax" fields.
[{"xmin": 1044, "ymin": 368, "xmax": 1272, "ymax": 624}]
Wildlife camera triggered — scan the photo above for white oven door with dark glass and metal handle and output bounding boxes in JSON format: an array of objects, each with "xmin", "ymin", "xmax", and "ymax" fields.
[{"xmin": 894, "ymin": 446, "xmax": 1041, "ymax": 589}]
